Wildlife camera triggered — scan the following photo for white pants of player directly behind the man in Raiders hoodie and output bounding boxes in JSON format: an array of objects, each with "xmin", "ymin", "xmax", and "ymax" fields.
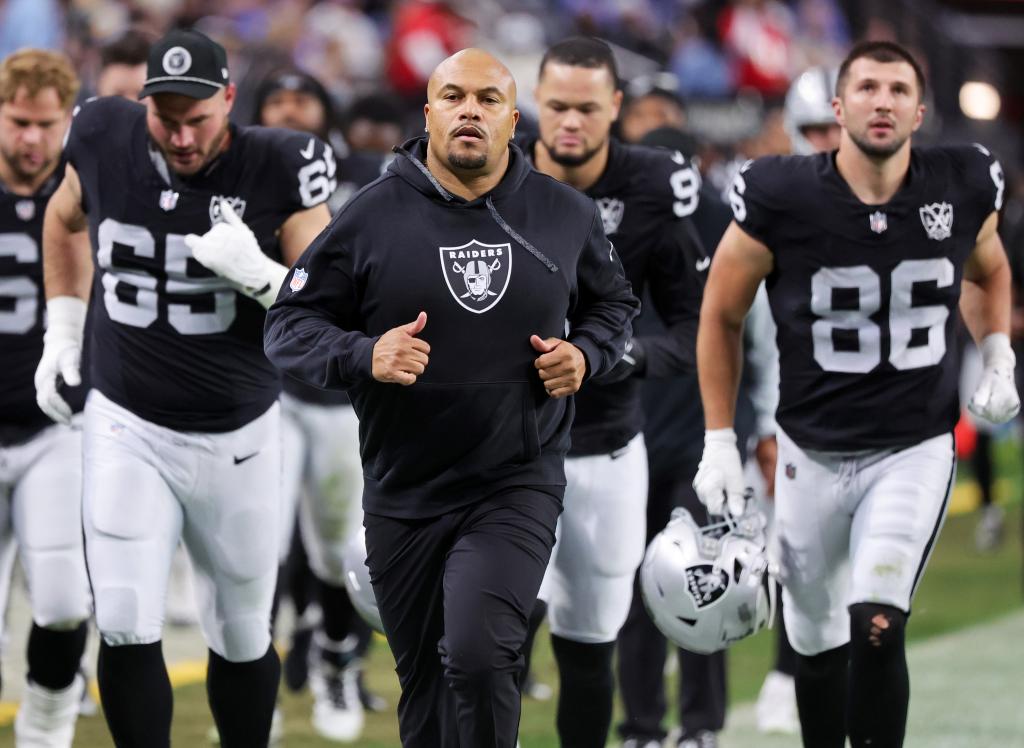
[{"xmin": 538, "ymin": 434, "xmax": 647, "ymax": 643}]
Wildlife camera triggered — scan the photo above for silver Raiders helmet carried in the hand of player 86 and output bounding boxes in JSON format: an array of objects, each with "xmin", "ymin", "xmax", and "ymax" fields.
[{"xmin": 640, "ymin": 508, "xmax": 775, "ymax": 655}]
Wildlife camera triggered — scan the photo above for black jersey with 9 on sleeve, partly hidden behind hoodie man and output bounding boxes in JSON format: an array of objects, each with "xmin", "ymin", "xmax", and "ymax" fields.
[{"xmin": 526, "ymin": 139, "xmax": 705, "ymax": 456}]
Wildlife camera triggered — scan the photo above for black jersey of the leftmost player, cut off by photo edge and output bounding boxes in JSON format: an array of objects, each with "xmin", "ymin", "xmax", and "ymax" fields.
[{"xmin": 0, "ymin": 164, "xmax": 84, "ymax": 444}]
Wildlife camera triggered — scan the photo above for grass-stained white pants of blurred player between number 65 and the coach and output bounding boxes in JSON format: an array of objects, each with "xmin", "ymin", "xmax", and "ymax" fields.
[{"xmin": 281, "ymin": 394, "xmax": 362, "ymax": 587}]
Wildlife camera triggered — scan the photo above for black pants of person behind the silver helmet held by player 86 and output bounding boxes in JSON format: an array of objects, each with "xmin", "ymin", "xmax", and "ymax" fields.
[{"xmin": 617, "ymin": 463, "xmax": 726, "ymax": 740}]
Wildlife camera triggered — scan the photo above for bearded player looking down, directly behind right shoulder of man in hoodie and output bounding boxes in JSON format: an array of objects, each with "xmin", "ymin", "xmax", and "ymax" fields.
[{"xmin": 524, "ymin": 37, "xmax": 702, "ymax": 746}]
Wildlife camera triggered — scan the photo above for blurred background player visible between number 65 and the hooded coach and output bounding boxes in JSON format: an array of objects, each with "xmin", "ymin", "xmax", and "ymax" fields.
[{"xmin": 256, "ymin": 65, "xmax": 387, "ymax": 741}]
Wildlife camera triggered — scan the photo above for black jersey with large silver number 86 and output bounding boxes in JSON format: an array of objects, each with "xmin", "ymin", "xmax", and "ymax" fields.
[{"xmin": 730, "ymin": 146, "xmax": 1004, "ymax": 452}]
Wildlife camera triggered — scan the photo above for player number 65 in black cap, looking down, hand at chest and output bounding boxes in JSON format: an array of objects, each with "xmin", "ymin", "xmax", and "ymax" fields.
[{"xmin": 36, "ymin": 31, "xmax": 335, "ymax": 748}]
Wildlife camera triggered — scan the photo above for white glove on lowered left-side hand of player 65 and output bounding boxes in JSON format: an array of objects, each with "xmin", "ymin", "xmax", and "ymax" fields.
[{"xmin": 35, "ymin": 296, "xmax": 87, "ymax": 425}]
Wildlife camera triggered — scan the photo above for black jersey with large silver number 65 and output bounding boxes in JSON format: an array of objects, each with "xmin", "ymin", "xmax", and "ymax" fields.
[{"xmin": 67, "ymin": 97, "xmax": 336, "ymax": 431}]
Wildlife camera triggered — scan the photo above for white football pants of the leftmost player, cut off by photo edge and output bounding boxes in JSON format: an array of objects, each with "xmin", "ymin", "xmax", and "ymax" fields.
[{"xmin": 0, "ymin": 424, "xmax": 90, "ymax": 629}]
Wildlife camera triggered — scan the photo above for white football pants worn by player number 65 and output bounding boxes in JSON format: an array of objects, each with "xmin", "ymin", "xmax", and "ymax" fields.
[{"xmin": 84, "ymin": 389, "xmax": 282, "ymax": 662}]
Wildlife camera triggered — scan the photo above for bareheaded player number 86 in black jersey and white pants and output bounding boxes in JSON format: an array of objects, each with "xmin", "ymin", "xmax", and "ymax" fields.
[{"xmin": 694, "ymin": 42, "xmax": 1020, "ymax": 748}]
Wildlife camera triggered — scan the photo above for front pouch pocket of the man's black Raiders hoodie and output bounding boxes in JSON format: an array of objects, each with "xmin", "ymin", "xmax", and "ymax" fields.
[{"xmin": 359, "ymin": 382, "xmax": 541, "ymax": 489}]
